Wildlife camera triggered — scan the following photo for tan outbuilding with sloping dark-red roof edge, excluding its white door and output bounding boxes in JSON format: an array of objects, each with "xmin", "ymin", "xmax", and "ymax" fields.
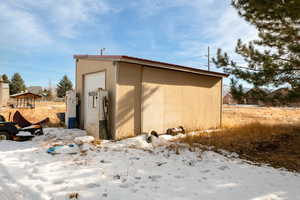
[{"xmin": 74, "ymin": 55, "xmax": 227, "ymax": 139}]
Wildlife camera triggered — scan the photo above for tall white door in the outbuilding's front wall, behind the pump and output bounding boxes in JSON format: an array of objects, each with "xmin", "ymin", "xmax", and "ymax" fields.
[{"xmin": 84, "ymin": 72, "xmax": 105, "ymax": 138}]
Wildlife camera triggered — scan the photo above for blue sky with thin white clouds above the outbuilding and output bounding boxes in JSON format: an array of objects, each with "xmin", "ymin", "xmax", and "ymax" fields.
[{"xmin": 0, "ymin": 0, "xmax": 256, "ymax": 87}]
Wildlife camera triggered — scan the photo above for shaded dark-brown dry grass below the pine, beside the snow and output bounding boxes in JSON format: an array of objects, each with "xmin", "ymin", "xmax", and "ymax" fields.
[{"xmin": 181, "ymin": 122, "xmax": 300, "ymax": 172}]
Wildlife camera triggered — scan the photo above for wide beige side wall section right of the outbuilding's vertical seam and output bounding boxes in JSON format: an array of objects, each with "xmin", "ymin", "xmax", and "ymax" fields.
[{"xmin": 142, "ymin": 67, "xmax": 222, "ymax": 132}]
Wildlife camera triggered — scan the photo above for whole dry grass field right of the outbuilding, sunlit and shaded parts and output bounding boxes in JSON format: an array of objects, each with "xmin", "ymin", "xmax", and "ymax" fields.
[{"xmin": 181, "ymin": 106, "xmax": 300, "ymax": 172}]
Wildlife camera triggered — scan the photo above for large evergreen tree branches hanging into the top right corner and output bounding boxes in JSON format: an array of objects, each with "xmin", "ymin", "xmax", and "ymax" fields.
[{"xmin": 213, "ymin": 0, "xmax": 300, "ymax": 91}]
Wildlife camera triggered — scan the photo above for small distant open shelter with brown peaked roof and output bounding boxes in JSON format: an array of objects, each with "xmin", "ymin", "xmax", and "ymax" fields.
[{"xmin": 10, "ymin": 92, "xmax": 42, "ymax": 109}]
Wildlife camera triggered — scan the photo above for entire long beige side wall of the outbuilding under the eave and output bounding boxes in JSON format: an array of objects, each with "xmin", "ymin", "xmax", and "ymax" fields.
[{"xmin": 116, "ymin": 62, "xmax": 222, "ymax": 139}]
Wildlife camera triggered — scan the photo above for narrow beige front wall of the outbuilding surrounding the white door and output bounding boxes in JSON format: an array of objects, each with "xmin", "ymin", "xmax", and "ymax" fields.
[{"xmin": 76, "ymin": 59, "xmax": 117, "ymax": 136}]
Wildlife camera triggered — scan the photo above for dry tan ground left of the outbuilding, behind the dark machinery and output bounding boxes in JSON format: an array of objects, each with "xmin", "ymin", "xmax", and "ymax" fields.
[{"xmin": 0, "ymin": 101, "xmax": 66, "ymax": 126}]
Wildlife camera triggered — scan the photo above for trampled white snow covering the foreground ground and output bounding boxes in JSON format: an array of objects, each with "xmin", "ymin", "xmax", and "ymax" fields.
[{"xmin": 0, "ymin": 128, "xmax": 300, "ymax": 200}]
